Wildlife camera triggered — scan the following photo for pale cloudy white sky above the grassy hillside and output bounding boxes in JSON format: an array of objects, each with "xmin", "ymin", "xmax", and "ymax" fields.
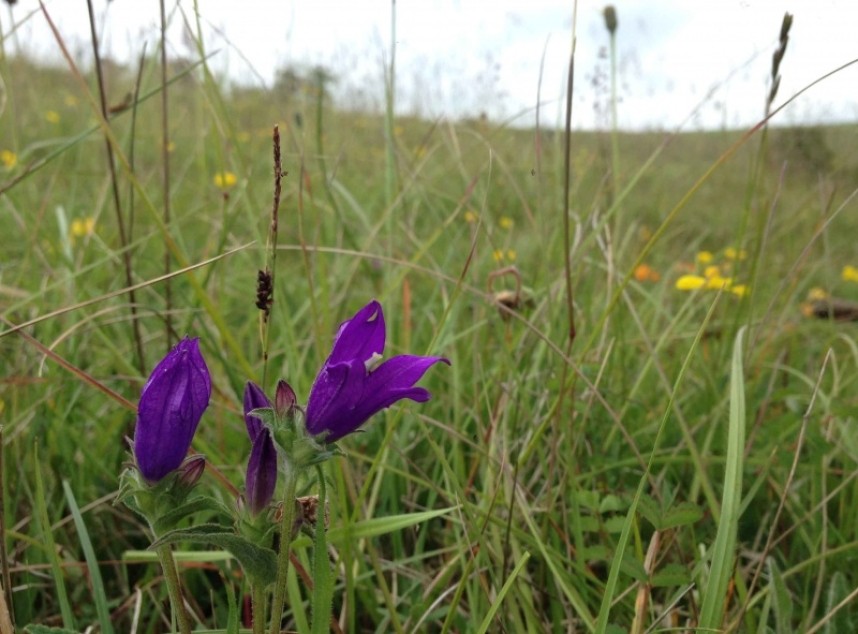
[{"xmin": 0, "ymin": 0, "xmax": 858, "ymax": 131}]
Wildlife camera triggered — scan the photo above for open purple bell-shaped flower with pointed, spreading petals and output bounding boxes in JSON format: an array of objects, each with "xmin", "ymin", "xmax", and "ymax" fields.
[{"xmin": 306, "ymin": 300, "xmax": 450, "ymax": 443}]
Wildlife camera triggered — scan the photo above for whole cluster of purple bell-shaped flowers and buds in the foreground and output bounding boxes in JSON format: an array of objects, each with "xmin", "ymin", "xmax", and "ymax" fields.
[{"xmin": 133, "ymin": 301, "xmax": 450, "ymax": 516}]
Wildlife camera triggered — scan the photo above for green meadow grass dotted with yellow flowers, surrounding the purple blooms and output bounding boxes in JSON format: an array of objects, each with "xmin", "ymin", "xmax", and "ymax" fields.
[{"xmin": 0, "ymin": 11, "xmax": 858, "ymax": 632}]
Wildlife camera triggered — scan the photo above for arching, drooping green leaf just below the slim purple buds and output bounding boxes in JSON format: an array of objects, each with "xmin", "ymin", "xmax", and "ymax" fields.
[{"xmin": 149, "ymin": 524, "xmax": 277, "ymax": 587}]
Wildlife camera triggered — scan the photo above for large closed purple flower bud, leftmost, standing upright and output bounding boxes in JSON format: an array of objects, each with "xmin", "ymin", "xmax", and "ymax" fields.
[{"xmin": 134, "ymin": 337, "xmax": 212, "ymax": 483}]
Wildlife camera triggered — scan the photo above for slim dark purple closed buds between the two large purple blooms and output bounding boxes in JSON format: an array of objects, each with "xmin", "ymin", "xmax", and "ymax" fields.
[{"xmin": 244, "ymin": 381, "xmax": 277, "ymax": 515}]
